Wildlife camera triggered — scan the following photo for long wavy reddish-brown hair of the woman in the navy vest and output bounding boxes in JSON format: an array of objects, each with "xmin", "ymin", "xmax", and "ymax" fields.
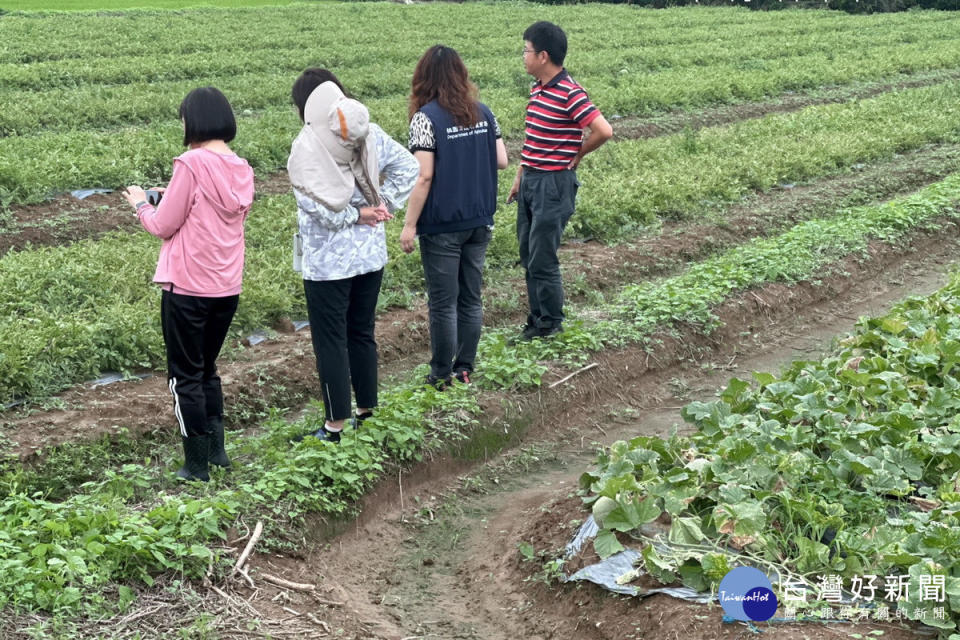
[{"xmin": 408, "ymin": 44, "xmax": 480, "ymax": 127}]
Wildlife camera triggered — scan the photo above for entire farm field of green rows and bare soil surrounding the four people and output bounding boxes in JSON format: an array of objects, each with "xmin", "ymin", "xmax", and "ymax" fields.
[{"xmin": 0, "ymin": 2, "xmax": 960, "ymax": 640}]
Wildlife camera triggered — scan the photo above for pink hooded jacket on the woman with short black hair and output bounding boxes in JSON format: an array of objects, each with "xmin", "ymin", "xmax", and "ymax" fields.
[{"xmin": 137, "ymin": 148, "xmax": 253, "ymax": 298}]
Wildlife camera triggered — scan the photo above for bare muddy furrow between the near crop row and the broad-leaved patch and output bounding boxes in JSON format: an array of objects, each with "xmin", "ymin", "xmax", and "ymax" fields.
[{"xmin": 0, "ymin": 196, "xmax": 960, "ymax": 640}]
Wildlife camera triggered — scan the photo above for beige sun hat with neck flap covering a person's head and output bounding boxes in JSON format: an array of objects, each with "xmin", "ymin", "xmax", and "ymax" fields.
[{"xmin": 287, "ymin": 82, "xmax": 380, "ymax": 211}]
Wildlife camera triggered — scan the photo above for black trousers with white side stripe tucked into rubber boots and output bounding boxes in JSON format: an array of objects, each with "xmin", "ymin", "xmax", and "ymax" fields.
[{"xmin": 160, "ymin": 291, "xmax": 240, "ymax": 438}]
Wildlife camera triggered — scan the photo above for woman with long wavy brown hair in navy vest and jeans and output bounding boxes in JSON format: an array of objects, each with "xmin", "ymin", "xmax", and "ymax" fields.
[{"xmin": 400, "ymin": 45, "xmax": 507, "ymax": 388}]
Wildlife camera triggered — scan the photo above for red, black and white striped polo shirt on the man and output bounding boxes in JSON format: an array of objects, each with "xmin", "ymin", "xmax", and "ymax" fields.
[{"xmin": 520, "ymin": 69, "xmax": 600, "ymax": 171}]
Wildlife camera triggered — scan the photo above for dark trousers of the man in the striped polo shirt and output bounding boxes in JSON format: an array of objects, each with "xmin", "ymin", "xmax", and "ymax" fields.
[{"xmin": 517, "ymin": 169, "xmax": 580, "ymax": 329}]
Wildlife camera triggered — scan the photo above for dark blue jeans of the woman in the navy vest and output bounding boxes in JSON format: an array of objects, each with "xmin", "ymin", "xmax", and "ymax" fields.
[{"xmin": 420, "ymin": 226, "xmax": 492, "ymax": 378}]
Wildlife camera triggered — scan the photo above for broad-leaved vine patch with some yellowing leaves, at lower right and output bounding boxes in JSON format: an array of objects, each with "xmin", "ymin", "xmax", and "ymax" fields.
[{"xmin": 581, "ymin": 276, "xmax": 960, "ymax": 640}]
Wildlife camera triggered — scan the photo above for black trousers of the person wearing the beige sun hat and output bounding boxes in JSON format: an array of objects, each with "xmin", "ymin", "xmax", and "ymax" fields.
[{"xmin": 303, "ymin": 269, "xmax": 383, "ymax": 421}]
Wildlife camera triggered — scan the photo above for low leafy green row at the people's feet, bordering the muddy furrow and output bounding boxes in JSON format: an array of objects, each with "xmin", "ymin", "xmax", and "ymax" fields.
[{"xmin": 0, "ymin": 168, "xmax": 960, "ymax": 628}]
